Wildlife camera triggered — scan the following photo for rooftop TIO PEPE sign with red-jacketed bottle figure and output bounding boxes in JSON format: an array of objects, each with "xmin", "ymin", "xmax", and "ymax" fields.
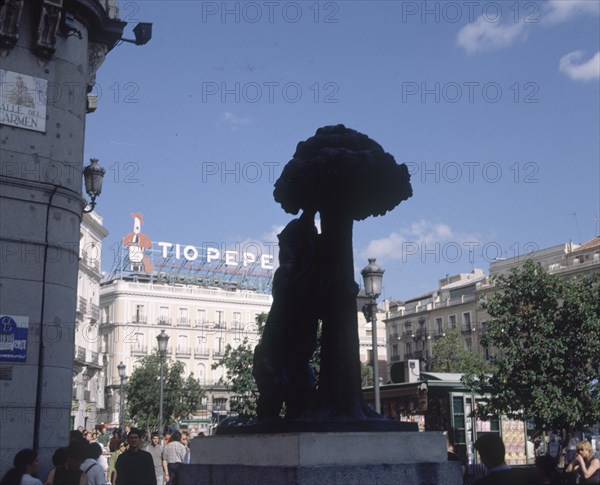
[{"xmin": 123, "ymin": 212, "xmax": 273, "ymax": 274}]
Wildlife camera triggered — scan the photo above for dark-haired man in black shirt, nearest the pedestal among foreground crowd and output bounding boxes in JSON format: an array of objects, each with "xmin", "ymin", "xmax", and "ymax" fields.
[{"xmin": 115, "ymin": 428, "xmax": 156, "ymax": 485}]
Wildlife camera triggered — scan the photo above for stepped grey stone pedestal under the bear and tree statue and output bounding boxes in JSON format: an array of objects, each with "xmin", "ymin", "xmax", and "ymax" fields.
[{"xmin": 179, "ymin": 432, "xmax": 463, "ymax": 485}]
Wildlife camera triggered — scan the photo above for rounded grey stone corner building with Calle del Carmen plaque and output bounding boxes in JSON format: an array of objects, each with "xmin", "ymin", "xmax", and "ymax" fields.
[{"xmin": 0, "ymin": 0, "xmax": 126, "ymax": 477}]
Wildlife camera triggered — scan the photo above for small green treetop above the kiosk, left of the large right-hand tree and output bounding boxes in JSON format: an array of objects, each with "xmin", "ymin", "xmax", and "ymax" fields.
[{"xmin": 431, "ymin": 328, "xmax": 490, "ymax": 375}]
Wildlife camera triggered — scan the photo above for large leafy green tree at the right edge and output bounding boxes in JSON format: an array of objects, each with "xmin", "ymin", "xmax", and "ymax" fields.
[{"xmin": 472, "ymin": 261, "xmax": 600, "ymax": 430}]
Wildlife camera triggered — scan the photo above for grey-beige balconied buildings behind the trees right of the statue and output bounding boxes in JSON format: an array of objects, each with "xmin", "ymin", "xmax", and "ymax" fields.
[{"xmin": 385, "ymin": 237, "xmax": 600, "ymax": 375}]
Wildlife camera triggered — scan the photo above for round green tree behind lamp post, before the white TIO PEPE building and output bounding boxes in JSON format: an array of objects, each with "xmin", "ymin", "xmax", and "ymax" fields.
[{"xmin": 125, "ymin": 352, "xmax": 205, "ymax": 430}]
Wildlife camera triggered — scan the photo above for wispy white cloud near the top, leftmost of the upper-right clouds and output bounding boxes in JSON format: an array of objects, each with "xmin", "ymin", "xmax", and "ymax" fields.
[{"xmin": 456, "ymin": 16, "xmax": 527, "ymax": 54}]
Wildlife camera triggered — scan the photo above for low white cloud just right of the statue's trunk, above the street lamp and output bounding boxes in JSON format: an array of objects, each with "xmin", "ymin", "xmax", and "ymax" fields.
[{"xmin": 360, "ymin": 220, "xmax": 480, "ymax": 261}]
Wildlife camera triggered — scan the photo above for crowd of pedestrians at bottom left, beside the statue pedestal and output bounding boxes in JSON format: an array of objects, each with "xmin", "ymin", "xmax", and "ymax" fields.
[{"xmin": 0, "ymin": 426, "xmax": 195, "ymax": 485}]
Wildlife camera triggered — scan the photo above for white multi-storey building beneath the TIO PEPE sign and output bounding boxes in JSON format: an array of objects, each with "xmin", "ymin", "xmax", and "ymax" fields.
[{"xmin": 98, "ymin": 278, "xmax": 272, "ymax": 423}]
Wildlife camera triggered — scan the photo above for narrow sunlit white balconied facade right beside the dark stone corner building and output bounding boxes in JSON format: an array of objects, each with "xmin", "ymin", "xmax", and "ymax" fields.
[{"xmin": 71, "ymin": 212, "xmax": 108, "ymax": 429}]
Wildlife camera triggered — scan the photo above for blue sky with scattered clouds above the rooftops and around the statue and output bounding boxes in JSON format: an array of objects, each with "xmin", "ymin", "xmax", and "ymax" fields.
[{"xmin": 85, "ymin": 0, "xmax": 600, "ymax": 299}]
